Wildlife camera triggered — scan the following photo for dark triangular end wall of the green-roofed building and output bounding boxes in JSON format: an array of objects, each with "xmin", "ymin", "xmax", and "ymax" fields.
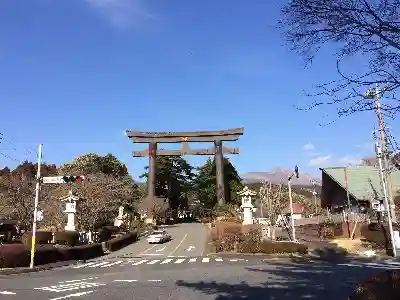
[{"xmin": 321, "ymin": 172, "xmax": 354, "ymax": 208}]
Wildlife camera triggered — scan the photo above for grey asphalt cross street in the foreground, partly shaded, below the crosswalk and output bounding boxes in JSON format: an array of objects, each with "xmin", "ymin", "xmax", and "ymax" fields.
[{"xmin": 0, "ymin": 255, "xmax": 400, "ymax": 300}]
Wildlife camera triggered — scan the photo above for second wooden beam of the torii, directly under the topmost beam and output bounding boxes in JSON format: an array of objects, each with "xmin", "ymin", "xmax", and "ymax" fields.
[{"xmin": 130, "ymin": 134, "xmax": 240, "ymax": 144}]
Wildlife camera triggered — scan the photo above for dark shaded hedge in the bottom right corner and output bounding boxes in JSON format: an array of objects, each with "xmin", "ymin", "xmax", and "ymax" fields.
[{"xmin": 348, "ymin": 270, "xmax": 400, "ymax": 300}]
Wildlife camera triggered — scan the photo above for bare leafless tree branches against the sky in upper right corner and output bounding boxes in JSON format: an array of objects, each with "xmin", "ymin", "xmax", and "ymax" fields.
[{"xmin": 279, "ymin": 0, "xmax": 400, "ymax": 117}]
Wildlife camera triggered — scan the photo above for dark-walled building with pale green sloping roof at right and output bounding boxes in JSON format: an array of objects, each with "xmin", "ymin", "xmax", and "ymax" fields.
[{"xmin": 320, "ymin": 166, "xmax": 400, "ymax": 207}]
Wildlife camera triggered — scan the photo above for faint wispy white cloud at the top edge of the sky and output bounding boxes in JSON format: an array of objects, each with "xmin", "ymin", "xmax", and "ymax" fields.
[{"xmin": 84, "ymin": 0, "xmax": 153, "ymax": 28}]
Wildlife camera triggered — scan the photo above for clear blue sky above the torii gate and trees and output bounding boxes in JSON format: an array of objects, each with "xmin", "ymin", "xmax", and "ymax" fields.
[{"xmin": 0, "ymin": 0, "xmax": 392, "ymax": 177}]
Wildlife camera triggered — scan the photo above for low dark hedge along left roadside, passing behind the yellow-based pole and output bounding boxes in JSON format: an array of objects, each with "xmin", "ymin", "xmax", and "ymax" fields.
[{"xmin": 0, "ymin": 244, "xmax": 104, "ymax": 268}]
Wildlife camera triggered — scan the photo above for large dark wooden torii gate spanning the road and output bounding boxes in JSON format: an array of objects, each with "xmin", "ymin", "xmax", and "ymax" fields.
[{"xmin": 126, "ymin": 128, "xmax": 244, "ymax": 204}]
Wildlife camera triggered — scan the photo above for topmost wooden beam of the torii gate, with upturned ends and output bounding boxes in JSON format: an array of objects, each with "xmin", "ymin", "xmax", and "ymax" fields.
[{"xmin": 126, "ymin": 127, "xmax": 244, "ymax": 138}]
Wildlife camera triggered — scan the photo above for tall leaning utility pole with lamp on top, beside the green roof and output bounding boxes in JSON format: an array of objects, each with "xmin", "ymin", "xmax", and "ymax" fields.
[{"xmin": 365, "ymin": 86, "xmax": 396, "ymax": 222}]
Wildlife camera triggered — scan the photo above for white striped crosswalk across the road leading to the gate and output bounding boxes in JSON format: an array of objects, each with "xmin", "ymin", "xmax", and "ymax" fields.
[{"xmin": 72, "ymin": 257, "xmax": 247, "ymax": 269}]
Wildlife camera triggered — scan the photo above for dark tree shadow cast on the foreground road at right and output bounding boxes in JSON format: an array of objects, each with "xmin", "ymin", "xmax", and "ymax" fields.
[{"xmin": 176, "ymin": 260, "xmax": 384, "ymax": 300}]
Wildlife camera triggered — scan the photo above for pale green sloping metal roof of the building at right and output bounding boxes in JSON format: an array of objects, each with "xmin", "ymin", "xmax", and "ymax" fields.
[{"xmin": 321, "ymin": 166, "xmax": 400, "ymax": 200}]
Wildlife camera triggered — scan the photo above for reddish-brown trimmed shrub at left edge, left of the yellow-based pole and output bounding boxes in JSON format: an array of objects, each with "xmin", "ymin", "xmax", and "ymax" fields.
[{"xmin": 0, "ymin": 244, "xmax": 30, "ymax": 268}]
